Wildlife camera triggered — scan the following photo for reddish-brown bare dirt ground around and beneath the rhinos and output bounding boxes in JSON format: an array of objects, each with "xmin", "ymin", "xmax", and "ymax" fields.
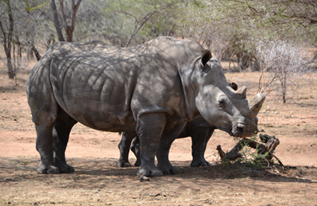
[{"xmin": 0, "ymin": 63, "xmax": 317, "ymax": 205}]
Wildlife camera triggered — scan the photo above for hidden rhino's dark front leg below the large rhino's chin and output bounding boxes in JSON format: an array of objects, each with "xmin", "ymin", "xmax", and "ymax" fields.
[{"xmin": 190, "ymin": 127, "xmax": 214, "ymax": 167}]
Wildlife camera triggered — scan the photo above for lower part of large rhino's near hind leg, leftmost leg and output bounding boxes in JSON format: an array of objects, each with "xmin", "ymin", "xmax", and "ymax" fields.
[{"xmin": 35, "ymin": 125, "xmax": 60, "ymax": 174}]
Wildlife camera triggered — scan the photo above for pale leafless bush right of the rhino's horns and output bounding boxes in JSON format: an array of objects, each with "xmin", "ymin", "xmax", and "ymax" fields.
[{"xmin": 257, "ymin": 40, "xmax": 311, "ymax": 103}]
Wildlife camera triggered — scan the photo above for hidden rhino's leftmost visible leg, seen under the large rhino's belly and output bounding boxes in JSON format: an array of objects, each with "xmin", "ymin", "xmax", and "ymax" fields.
[{"xmin": 117, "ymin": 132, "xmax": 136, "ymax": 167}]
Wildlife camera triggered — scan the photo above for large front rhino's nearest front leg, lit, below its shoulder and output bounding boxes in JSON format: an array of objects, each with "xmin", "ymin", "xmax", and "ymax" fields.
[{"xmin": 136, "ymin": 113, "xmax": 166, "ymax": 177}]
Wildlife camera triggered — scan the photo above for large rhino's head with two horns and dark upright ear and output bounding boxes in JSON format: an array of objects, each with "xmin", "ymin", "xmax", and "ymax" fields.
[{"xmin": 195, "ymin": 51, "xmax": 265, "ymax": 138}]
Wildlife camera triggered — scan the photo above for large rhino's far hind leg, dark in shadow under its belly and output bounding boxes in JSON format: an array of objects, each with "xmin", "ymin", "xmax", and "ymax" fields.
[{"xmin": 52, "ymin": 108, "xmax": 77, "ymax": 173}]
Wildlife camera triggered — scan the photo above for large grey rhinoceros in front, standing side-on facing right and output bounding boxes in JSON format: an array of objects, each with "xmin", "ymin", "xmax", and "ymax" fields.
[{"xmin": 27, "ymin": 37, "xmax": 265, "ymax": 176}]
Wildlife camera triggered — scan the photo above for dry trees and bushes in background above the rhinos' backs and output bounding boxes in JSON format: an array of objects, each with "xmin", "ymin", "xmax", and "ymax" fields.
[{"xmin": 0, "ymin": 0, "xmax": 317, "ymax": 102}]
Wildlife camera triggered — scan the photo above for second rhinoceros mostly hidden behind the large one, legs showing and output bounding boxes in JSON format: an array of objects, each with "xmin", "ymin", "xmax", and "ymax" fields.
[{"xmin": 117, "ymin": 82, "xmax": 247, "ymax": 174}]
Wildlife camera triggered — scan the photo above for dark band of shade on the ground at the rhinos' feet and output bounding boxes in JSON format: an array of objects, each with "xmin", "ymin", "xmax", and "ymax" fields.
[{"xmin": 0, "ymin": 157, "xmax": 317, "ymax": 187}]
